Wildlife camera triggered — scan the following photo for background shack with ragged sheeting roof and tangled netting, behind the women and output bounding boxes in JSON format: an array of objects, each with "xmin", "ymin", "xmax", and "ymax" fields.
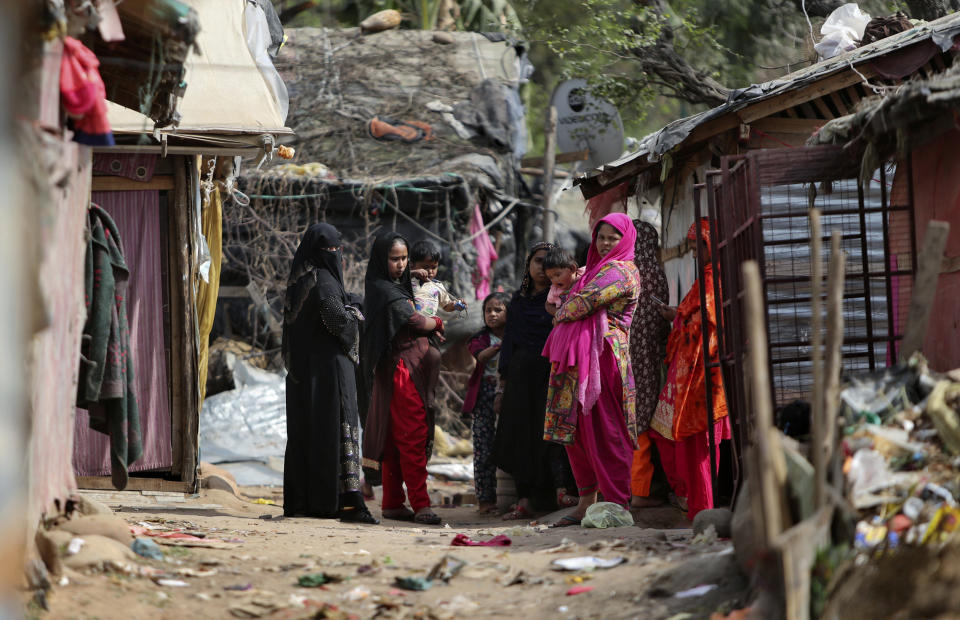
[{"xmin": 230, "ymin": 28, "xmax": 538, "ymax": 342}]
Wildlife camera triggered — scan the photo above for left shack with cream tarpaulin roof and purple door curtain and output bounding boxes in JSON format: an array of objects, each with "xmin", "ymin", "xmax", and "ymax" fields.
[{"xmin": 10, "ymin": 0, "xmax": 292, "ymax": 502}]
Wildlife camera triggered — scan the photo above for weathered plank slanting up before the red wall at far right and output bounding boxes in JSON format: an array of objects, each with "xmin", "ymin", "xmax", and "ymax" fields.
[{"xmin": 900, "ymin": 220, "xmax": 950, "ymax": 362}]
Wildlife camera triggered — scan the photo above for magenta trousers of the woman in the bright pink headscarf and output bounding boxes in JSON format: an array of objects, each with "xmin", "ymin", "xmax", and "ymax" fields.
[{"xmin": 567, "ymin": 347, "xmax": 634, "ymax": 506}]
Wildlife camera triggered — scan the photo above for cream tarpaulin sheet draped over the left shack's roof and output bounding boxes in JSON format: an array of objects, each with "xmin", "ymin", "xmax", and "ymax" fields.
[{"xmin": 107, "ymin": 0, "xmax": 292, "ymax": 135}]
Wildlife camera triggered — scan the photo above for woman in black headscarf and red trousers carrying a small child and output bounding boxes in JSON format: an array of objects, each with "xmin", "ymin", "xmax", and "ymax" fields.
[{"xmin": 360, "ymin": 232, "xmax": 443, "ymax": 525}]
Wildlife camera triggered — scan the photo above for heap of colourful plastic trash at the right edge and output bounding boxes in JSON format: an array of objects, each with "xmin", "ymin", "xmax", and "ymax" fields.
[{"xmin": 840, "ymin": 355, "xmax": 960, "ymax": 554}]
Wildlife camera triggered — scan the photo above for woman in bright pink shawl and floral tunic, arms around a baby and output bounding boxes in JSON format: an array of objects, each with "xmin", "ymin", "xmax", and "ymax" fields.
[{"xmin": 543, "ymin": 213, "xmax": 639, "ymax": 527}]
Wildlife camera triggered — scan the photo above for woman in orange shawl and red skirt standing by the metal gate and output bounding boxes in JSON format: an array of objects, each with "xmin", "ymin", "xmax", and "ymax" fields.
[{"xmin": 650, "ymin": 218, "xmax": 730, "ymax": 519}]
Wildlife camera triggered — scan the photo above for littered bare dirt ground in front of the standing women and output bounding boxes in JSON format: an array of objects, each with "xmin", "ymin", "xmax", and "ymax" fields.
[{"xmin": 27, "ymin": 488, "xmax": 746, "ymax": 620}]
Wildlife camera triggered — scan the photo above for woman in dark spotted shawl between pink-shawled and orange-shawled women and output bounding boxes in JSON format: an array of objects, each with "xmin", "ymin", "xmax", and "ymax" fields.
[{"xmin": 630, "ymin": 220, "xmax": 670, "ymax": 508}]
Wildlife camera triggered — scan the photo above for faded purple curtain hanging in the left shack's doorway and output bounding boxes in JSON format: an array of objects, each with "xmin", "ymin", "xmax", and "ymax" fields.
[{"xmin": 73, "ymin": 191, "xmax": 173, "ymax": 476}]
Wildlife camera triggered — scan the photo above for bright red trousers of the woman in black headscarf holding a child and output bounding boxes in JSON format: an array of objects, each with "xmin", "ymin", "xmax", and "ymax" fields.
[{"xmin": 382, "ymin": 359, "xmax": 430, "ymax": 512}]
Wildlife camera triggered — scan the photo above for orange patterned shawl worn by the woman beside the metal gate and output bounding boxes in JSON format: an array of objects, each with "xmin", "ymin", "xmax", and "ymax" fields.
[{"xmin": 650, "ymin": 219, "xmax": 727, "ymax": 441}]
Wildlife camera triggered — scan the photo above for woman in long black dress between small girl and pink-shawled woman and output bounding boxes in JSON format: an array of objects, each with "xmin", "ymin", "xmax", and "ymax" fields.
[{"xmin": 494, "ymin": 243, "xmax": 576, "ymax": 520}]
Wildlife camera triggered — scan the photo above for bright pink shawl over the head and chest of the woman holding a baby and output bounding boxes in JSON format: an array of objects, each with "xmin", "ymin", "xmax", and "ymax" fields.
[{"xmin": 543, "ymin": 213, "xmax": 637, "ymax": 411}]
